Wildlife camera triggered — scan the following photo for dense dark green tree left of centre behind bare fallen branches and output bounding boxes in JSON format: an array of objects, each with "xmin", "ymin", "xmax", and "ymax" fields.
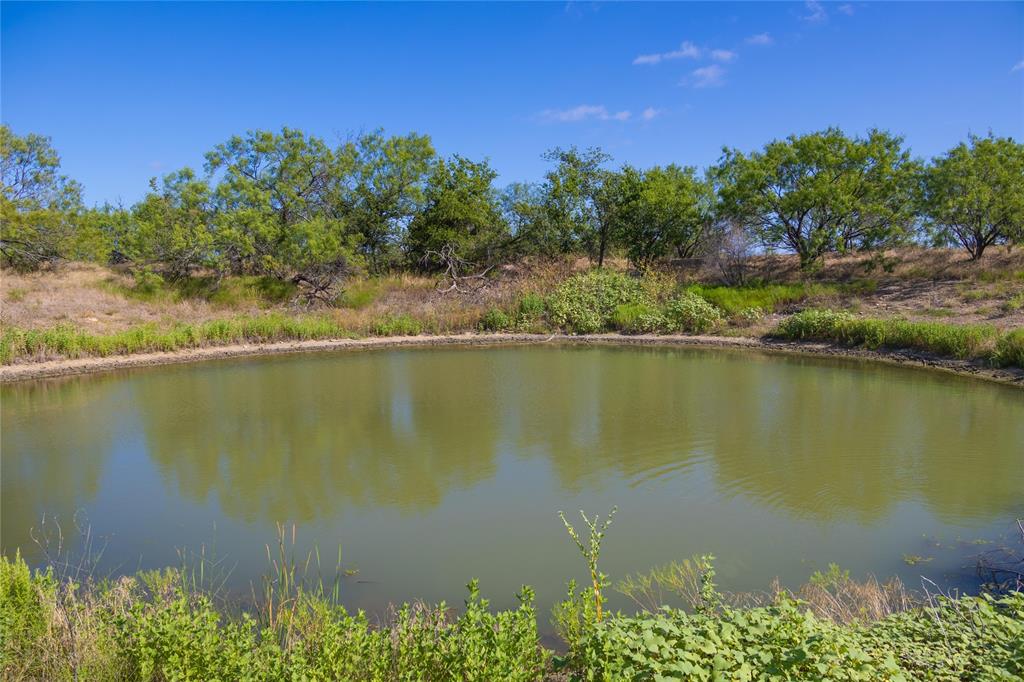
[{"xmin": 408, "ymin": 155, "xmax": 509, "ymax": 264}]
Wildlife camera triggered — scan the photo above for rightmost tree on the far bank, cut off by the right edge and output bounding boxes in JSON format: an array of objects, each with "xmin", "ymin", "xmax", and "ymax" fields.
[{"xmin": 924, "ymin": 133, "xmax": 1024, "ymax": 260}]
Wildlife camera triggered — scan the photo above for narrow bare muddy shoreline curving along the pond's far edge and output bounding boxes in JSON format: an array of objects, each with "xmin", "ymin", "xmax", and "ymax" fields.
[{"xmin": 0, "ymin": 334, "xmax": 1024, "ymax": 388}]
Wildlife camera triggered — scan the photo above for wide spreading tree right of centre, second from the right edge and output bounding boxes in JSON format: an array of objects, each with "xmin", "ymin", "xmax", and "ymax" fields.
[{"xmin": 713, "ymin": 128, "xmax": 920, "ymax": 268}]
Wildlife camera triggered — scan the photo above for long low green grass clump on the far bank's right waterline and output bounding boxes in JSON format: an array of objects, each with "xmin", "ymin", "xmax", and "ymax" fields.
[{"xmin": 774, "ymin": 310, "xmax": 999, "ymax": 359}]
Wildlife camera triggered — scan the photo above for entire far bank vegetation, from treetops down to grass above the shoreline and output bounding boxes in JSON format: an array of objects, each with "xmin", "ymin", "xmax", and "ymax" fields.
[{"xmin": 0, "ymin": 126, "xmax": 1024, "ymax": 378}]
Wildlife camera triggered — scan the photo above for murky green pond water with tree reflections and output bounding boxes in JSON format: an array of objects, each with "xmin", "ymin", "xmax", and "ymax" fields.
[{"xmin": 0, "ymin": 346, "xmax": 1024, "ymax": 627}]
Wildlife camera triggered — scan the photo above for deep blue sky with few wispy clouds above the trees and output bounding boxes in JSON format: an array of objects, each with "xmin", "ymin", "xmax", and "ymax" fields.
[{"xmin": 6, "ymin": 2, "xmax": 1024, "ymax": 203}]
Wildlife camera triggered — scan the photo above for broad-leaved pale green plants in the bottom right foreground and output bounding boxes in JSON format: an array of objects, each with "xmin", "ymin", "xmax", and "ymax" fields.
[{"xmin": 561, "ymin": 592, "xmax": 1024, "ymax": 682}]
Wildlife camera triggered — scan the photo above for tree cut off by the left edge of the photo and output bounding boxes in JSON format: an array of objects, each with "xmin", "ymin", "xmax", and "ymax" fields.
[{"xmin": 0, "ymin": 125, "xmax": 82, "ymax": 269}]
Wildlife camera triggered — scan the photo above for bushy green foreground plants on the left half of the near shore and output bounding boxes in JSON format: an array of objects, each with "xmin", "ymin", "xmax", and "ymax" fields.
[{"xmin": 0, "ymin": 555, "xmax": 550, "ymax": 682}]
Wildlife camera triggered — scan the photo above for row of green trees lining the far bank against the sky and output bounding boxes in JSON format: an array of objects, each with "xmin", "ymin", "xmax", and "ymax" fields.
[{"xmin": 0, "ymin": 126, "xmax": 1024, "ymax": 293}]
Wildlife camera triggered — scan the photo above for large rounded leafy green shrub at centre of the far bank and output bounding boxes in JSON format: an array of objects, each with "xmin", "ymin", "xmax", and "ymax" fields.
[{"xmin": 548, "ymin": 270, "xmax": 653, "ymax": 334}]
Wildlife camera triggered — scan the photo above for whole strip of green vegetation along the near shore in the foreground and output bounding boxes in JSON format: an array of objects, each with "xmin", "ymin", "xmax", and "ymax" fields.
[{"xmin": 0, "ymin": 510, "xmax": 1024, "ymax": 681}]
